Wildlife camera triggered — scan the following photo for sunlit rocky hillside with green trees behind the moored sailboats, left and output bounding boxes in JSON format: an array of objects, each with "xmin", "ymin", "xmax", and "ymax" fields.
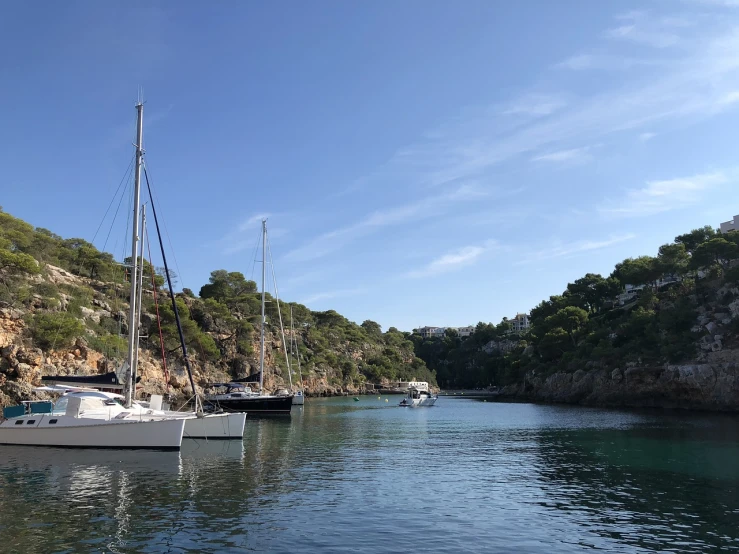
[{"xmin": 0, "ymin": 209, "xmax": 436, "ymax": 403}]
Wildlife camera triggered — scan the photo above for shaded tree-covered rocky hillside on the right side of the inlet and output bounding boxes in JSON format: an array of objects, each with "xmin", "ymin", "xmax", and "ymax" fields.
[{"xmin": 412, "ymin": 222, "xmax": 739, "ymax": 403}]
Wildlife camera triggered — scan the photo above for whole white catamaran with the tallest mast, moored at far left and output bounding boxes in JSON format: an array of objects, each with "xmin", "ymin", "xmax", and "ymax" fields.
[{"xmin": 0, "ymin": 102, "xmax": 246, "ymax": 444}]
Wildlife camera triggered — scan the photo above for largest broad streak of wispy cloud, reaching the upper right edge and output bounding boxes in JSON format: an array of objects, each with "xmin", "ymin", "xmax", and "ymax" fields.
[{"xmin": 362, "ymin": 14, "xmax": 739, "ymax": 192}]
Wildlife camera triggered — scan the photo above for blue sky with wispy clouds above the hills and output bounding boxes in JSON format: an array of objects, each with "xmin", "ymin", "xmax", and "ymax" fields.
[{"xmin": 0, "ymin": 0, "xmax": 739, "ymax": 330}]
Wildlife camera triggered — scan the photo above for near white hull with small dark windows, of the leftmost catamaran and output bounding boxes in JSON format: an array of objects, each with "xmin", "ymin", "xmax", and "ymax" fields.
[{"xmin": 0, "ymin": 414, "xmax": 186, "ymax": 450}]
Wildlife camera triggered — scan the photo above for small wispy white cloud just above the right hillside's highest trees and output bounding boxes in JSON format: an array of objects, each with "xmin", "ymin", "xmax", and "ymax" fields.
[{"xmin": 598, "ymin": 172, "xmax": 728, "ymax": 217}]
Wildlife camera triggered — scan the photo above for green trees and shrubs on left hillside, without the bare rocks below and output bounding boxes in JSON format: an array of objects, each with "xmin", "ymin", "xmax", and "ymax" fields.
[{"xmin": 0, "ymin": 205, "xmax": 436, "ymax": 389}]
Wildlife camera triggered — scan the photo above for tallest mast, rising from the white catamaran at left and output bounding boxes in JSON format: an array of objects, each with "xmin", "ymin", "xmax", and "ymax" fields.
[{"xmin": 125, "ymin": 101, "xmax": 144, "ymax": 408}]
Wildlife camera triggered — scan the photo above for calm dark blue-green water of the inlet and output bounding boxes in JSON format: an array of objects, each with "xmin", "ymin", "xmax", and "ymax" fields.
[{"xmin": 0, "ymin": 397, "xmax": 739, "ymax": 553}]
